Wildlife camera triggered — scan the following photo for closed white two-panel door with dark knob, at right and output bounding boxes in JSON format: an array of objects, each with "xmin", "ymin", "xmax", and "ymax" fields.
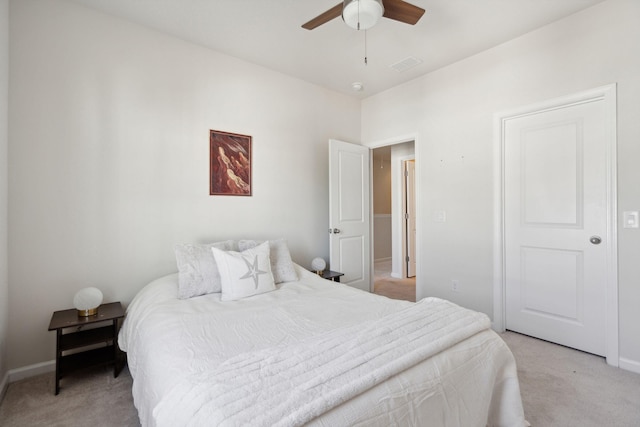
[{"xmin": 504, "ymin": 99, "xmax": 612, "ymax": 355}]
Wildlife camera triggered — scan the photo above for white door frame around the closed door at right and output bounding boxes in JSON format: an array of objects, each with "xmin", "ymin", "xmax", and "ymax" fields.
[{"xmin": 492, "ymin": 83, "xmax": 619, "ymax": 366}]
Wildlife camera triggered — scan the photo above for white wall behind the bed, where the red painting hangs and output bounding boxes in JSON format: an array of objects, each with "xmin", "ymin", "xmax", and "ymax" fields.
[{"xmin": 6, "ymin": 0, "xmax": 360, "ymax": 368}]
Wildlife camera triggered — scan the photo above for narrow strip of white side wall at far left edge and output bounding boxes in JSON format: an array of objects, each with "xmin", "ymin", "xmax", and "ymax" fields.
[{"xmin": 0, "ymin": 0, "xmax": 9, "ymax": 392}]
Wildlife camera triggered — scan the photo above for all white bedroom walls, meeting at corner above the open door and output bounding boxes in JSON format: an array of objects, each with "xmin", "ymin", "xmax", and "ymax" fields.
[{"xmin": 0, "ymin": 0, "xmax": 640, "ymax": 424}]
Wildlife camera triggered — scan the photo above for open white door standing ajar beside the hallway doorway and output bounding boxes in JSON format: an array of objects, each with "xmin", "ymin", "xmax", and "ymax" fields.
[{"xmin": 329, "ymin": 139, "xmax": 371, "ymax": 291}]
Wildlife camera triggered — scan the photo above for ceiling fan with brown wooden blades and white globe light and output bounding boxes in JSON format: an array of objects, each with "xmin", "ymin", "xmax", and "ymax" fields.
[{"xmin": 302, "ymin": 0, "xmax": 424, "ymax": 30}]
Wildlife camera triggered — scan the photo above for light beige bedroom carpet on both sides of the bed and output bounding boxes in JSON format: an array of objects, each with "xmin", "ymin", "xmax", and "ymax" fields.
[{"xmin": 0, "ymin": 332, "xmax": 640, "ymax": 427}]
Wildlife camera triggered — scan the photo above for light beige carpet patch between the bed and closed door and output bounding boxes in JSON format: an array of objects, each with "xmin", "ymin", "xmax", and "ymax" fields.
[{"xmin": 502, "ymin": 331, "xmax": 640, "ymax": 427}]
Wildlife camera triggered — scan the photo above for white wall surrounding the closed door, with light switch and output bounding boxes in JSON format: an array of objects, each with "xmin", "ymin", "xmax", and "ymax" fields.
[{"xmin": 362, "ymin": 0, "xmax": 640, "ymax": 372}]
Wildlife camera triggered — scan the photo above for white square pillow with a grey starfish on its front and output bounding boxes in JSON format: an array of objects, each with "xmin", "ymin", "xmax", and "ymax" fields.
[{"xmin": 211, "ymin": 242, "xmax": 276, "ymax": 301}]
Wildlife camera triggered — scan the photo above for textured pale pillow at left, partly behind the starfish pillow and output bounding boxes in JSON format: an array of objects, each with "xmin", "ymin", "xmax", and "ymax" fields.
[{"xmin": 174, "ymin": 240, "xmax": 233, "ymax": 299}]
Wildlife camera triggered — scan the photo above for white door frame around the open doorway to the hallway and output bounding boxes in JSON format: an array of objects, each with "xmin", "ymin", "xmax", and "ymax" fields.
[{"xmin": 362, "ymin": 133, "xmax": 422, "ymax": 290}]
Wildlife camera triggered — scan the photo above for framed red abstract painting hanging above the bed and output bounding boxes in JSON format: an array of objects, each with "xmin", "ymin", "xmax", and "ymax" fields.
[{"xmin": 209, "ymin": 130, "xmax": 251, "ymax": 196}]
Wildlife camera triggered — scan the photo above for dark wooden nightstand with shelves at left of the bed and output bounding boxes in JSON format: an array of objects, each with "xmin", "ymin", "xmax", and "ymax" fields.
[{"xmin": 49, "ymin": 302, "xmax": 124, "ymax": 395}]
